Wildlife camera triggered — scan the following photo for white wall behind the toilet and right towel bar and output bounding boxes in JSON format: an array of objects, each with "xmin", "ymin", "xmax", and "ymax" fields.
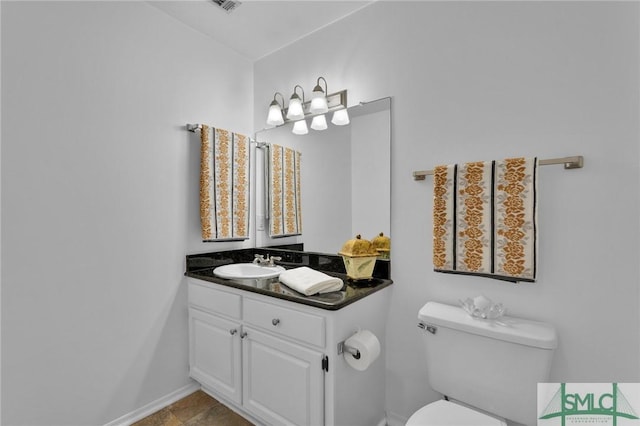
[{"xmin": 254, "ymin": 2, "xmax": 640, "ymax": 422}]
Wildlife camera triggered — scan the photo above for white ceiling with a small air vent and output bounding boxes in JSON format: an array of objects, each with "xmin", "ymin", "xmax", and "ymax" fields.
[{"xmin": 148, "ymin": 0, "xmax": 375, "ymax": 61}]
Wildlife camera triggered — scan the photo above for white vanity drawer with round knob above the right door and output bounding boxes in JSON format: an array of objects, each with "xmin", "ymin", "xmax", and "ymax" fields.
[{"xmin": 243, "ymin": 298, "xmax": 325, "ymax": 347}]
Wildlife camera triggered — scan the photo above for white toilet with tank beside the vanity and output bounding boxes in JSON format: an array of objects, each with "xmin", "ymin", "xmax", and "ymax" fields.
[{"xmin": 406, "ymin": 302, "xmax": 558, "ymax": 426}]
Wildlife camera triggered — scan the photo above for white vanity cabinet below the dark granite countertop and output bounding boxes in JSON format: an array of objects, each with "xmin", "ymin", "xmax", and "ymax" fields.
[{"xmin": 187, "ymin": 278, "xmax": 389, "ymax": 426}]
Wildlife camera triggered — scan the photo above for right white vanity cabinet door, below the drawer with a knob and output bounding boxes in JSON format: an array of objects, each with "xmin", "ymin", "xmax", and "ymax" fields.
[{"xmin": 242, "ymin": 327, "xmax": 324, "ymax": 426}]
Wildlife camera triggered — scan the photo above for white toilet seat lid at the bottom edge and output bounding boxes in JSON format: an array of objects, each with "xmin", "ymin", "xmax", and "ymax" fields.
[{"xmin": 406, "ymin": 399, "xmax": 507, "ymax": 426}]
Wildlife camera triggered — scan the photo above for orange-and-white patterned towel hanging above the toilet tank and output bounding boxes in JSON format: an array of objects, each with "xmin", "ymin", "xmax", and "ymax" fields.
[{"xmin": 433, "ymin": 158, "xmax": 538, "ymax": 282}]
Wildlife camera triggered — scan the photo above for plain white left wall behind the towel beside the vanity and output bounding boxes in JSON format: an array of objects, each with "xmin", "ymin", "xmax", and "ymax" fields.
[{"xmin": 2, "ymin": 2, "xmax": 253, "ymax": 426}]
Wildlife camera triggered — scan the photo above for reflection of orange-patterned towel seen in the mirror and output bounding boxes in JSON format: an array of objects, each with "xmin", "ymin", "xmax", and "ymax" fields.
[{"xmin": 269, "ymin": 144, "xmax": 302, "ymax": 238}]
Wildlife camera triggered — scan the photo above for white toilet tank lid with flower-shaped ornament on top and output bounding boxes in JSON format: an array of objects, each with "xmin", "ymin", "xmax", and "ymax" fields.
[{"xmin": 418, "ymin": 302, "xmax": 558, "ymax": 349}]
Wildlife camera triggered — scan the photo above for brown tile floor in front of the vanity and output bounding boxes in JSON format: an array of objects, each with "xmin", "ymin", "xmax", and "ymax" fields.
[{"xmin": 132, "ymin": 390, "xmax": 253, "ymax": 426}]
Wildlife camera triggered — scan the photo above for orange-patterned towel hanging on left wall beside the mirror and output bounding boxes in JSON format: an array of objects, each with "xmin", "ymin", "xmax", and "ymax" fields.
[{"xmin": 200, "ymin": 125, "xmax": 249, "ymax": 241}]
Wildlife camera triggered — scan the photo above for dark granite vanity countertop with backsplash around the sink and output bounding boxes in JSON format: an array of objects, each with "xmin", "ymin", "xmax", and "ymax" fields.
[{"xmin": 185, "ymin": 249, "xmax": 393, "ymax": 310}]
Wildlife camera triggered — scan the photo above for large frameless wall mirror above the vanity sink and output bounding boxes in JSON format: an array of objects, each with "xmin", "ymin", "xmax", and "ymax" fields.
[{"xmin": 254, "ymin": 98, "xmax": 391, "ymax": 254}]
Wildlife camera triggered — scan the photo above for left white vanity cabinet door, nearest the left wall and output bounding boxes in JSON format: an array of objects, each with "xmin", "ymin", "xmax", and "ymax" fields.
[{"xmin": 189, "ymin": 308, "xmax": 242, "ymax": 404}]
